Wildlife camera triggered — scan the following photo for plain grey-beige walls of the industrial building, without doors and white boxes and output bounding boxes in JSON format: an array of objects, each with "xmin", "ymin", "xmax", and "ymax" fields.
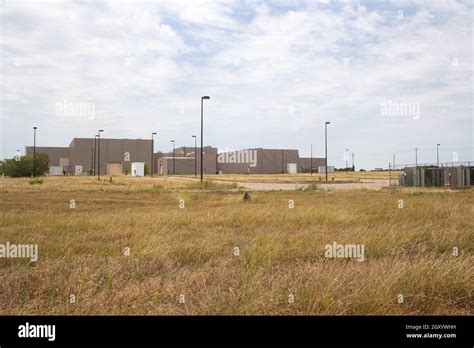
[{"xmin": 26, "ymin": 138, "xmax": 324, "ymax": 175}]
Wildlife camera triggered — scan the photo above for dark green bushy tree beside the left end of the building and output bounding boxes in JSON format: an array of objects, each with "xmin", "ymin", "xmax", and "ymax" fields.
[{"xmin": 0, "ymin": 153, "xmax": 49, "ymax": 178}]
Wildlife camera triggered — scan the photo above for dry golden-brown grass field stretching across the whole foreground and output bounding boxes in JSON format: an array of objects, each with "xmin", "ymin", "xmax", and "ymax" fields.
[{"xmin": 0, "ymin": 177, "xmax": 474, "ymax": 315}]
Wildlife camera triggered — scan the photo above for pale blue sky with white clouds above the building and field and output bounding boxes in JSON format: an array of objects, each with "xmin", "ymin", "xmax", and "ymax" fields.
[{"xmin": 0, "ymin": 0, "xmax": 474, "ymax": 169}]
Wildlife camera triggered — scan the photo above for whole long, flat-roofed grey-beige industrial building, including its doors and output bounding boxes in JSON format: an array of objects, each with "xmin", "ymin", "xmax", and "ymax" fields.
[{"xmin": 26, "ymin": 138, "xmax": 325, "ymax": 175}]
